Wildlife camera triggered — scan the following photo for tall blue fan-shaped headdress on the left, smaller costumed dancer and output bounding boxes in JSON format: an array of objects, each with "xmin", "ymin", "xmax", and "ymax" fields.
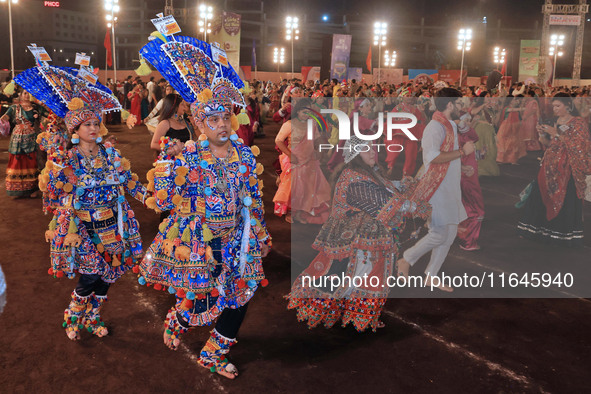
[{"xmin": 14, "ymin": 46, "xmax": 121, "ymax": 134}]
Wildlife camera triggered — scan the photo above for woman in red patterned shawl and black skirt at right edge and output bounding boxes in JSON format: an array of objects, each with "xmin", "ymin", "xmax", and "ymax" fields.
[{"xmin": 517, "ymin": 93, "xmax": 591, "ymax": 246}]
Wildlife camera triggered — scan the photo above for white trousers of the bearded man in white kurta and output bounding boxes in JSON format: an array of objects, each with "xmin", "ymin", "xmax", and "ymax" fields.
[{"xmin": 403, "ymin": 224, "xmax": 458, "ymax": 276}]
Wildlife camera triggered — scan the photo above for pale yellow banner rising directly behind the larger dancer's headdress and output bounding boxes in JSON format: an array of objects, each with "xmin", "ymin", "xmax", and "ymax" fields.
[{"xmin": 208, "ymin": 11, "xmax": 241, "ymax": 70}]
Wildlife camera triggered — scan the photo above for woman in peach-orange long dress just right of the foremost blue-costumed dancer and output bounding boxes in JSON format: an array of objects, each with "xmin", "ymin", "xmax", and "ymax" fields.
[{"xmin": 273, "ymin": 100, "xmax": 330, "ymax": 224}]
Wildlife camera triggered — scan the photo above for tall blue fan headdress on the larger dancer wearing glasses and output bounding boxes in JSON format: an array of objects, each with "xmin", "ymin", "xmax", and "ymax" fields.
[{"xmin": 140, "ymin": 16, "xmax": 249, "ymax": 130}]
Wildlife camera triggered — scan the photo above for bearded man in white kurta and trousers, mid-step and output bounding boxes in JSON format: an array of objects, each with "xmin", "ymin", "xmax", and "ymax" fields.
[{"xmin": 397, "ymin": 89, "xmax": 474, "ymax": 291}]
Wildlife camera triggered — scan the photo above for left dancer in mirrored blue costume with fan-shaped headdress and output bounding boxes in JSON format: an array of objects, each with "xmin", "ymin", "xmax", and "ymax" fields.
[{"xmin": 15, "ymin": 60, "xmax": 146, "ymax": 340}]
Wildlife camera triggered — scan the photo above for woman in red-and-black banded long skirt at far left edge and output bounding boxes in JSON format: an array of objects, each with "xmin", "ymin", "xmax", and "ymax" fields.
[{"xmin": 0, "ymin": 90, "xmax": 47, "ymax": 198}]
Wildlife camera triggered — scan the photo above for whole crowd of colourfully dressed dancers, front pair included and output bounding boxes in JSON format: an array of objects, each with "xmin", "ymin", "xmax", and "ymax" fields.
[{"xmin": 0, "ymin": 41, "xmax": 591, "ymax": 379}]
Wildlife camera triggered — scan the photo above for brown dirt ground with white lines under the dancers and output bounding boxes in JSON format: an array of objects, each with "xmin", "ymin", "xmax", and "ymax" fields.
[{"xmin": 0, "ymin": 124, "xmax": 591, "ymax": 393}]
